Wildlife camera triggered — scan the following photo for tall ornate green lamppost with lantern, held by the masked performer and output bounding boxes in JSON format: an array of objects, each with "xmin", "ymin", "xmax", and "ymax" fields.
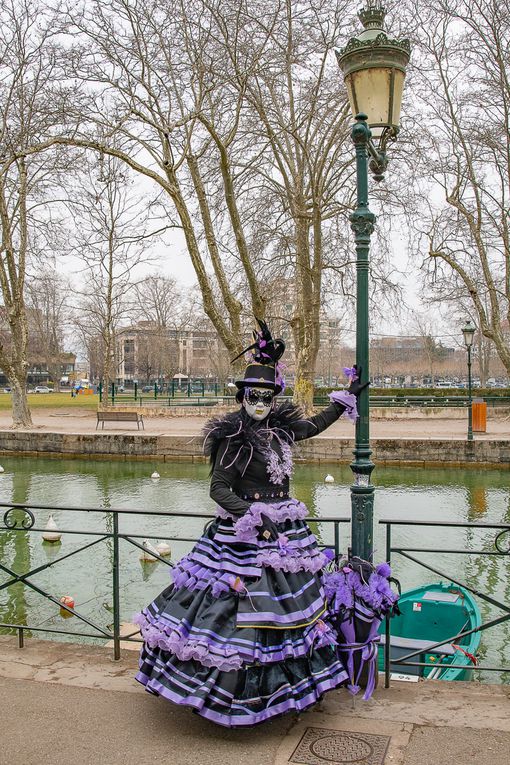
[{"xmin": 336, "ymin": 0, "xmax": 410, "ymax": 560}]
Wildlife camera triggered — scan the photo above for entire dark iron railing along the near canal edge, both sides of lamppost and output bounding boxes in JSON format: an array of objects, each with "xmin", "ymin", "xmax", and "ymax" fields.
[{"xmin": 0, "ymin": 502, "xmax": 510, "ymax": 687}]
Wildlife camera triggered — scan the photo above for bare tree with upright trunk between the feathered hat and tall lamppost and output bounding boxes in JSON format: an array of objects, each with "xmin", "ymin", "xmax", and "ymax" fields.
[{"xmin": 187, "ymin": 0, "xmax": 362, "ymax": 409}]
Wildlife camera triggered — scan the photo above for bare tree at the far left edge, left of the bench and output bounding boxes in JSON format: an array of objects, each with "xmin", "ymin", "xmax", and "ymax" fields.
[{"xmin": 0, "ymin": 0, "xmax": 69, "ymax": 427}]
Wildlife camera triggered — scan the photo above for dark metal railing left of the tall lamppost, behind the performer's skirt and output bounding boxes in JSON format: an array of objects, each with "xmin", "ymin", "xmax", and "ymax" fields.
[{"xmin": 0, "ymin": 502, "xmax": 350, "ymax": 660}]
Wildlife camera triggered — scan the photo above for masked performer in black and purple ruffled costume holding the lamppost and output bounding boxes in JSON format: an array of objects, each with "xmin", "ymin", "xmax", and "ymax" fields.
[{"xmin": 136, "ymin": 321, "xmax": 365, "ymax": 727}]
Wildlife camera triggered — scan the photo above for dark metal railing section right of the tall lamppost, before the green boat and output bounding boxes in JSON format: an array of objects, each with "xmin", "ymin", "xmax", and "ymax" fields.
[{"xmin": 379, "ymin": 519, "xmax": 510, "ymax": 688}]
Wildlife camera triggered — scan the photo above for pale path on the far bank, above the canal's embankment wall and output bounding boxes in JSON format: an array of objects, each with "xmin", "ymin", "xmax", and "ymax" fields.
[{"xmin": 0, "ymin": 408, "xmax": 510, "ymax": 440}]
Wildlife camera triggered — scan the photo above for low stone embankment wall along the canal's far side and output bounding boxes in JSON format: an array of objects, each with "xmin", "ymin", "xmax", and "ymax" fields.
[{"xmin": 0, "ymin": 430, "xmax": 510, "ymax": 467}]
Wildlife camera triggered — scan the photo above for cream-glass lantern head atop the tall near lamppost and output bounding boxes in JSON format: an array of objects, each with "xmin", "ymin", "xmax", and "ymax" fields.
[{"xmin": 335, "ymin": 0, "xmax": 411, "ymax": 146}]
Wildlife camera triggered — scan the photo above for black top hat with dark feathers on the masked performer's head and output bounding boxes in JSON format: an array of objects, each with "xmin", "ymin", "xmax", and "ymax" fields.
[{"xmin": 232, "ymin": 319, "xmax": 285, "ymax": 393}]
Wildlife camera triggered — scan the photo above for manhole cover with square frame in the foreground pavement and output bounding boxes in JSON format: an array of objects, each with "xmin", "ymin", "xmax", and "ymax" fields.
[{"xmin": 289, "ymin": 728, "xmax": 390, "ymax": 765}]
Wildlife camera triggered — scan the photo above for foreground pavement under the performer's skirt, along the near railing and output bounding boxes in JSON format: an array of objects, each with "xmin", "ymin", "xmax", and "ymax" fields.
[{"xmin": 0, "ymin": 637, "xmax": 510, "ymax": 765}]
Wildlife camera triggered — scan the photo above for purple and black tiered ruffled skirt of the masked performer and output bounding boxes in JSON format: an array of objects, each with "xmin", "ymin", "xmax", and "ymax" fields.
[{"xmin": 135, "ymin": 499, "xmax": 347, "ymax": 727}]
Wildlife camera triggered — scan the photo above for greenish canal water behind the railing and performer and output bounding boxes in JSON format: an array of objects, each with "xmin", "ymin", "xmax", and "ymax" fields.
[{"xmin": 0, "ymin": 457, "xmax": 510, "ymax": 683}]
